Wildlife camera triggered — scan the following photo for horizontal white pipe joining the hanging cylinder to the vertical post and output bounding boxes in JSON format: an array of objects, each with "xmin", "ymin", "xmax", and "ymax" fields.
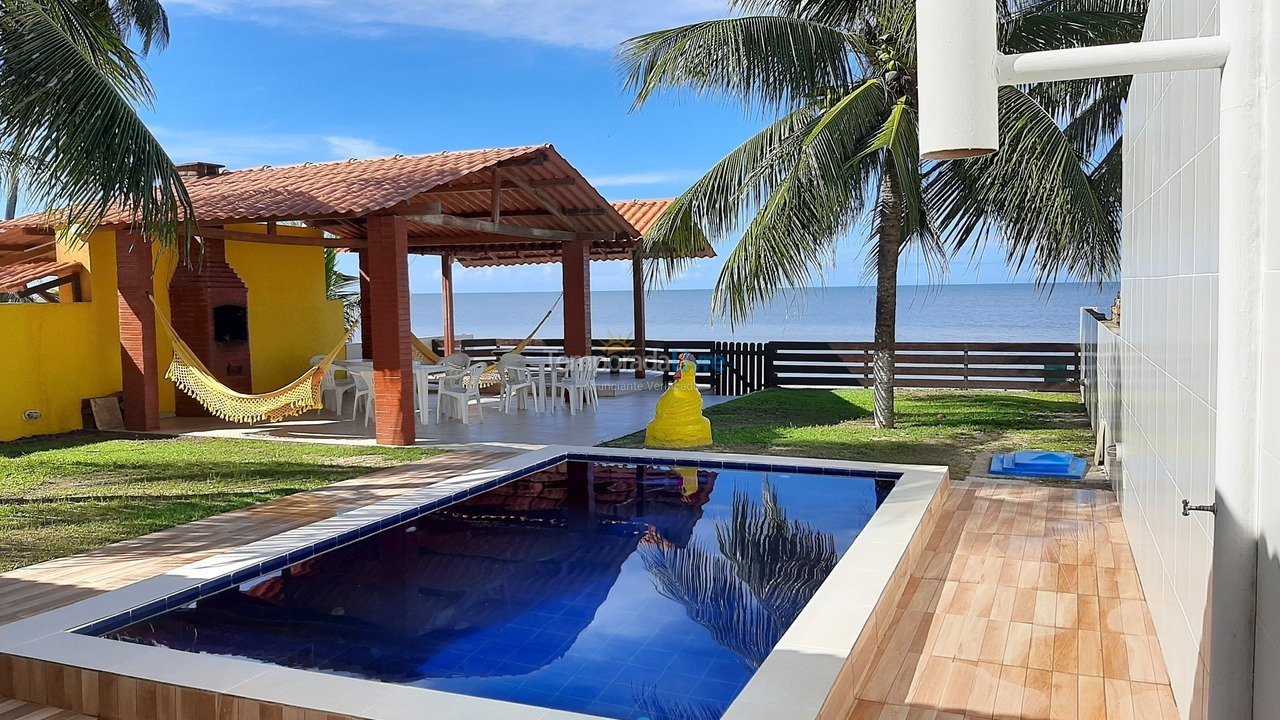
[{"xmin": 988, "ymin": 37, "xmax": 1230, "ymax": 85}]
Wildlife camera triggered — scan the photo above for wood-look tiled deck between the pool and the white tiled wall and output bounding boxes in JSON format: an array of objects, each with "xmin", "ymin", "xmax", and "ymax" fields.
[{"xmin": 846, "ymin": 482, "xmax": 1179, "ymax": 720}]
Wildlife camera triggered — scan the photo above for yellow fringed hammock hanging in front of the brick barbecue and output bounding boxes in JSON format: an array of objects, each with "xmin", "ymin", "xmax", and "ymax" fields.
[{"xmin": 152, "ymin": 299, "xmax": 355, "ymax": 424}]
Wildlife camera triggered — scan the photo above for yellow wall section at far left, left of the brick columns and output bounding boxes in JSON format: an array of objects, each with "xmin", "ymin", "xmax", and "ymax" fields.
[{"xmin": 0, "ymin": 232, "xmax": 120, "ymax": 441}]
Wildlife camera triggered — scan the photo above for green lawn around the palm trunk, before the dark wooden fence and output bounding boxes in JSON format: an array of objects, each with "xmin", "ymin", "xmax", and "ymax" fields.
[{"xmin": 608, "ymin": 389, "xmax": 1093, "ymax": 478}]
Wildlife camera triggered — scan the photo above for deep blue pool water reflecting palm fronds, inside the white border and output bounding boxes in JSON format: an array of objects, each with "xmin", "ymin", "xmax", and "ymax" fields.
[{"xmin": 105, "ymin": 460, "xmax": 892, "ymax": 720}]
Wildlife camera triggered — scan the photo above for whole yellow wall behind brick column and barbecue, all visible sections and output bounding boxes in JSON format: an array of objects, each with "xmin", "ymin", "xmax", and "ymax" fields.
[{"xmin": 0, "ymin": 225, "xmax": 343, "ymax": 442}]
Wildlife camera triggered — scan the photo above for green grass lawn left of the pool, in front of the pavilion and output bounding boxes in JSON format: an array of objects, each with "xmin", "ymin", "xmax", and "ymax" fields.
[{"xmin": 0, "ymin": 433, "xmax": 440, "ymax": 571}]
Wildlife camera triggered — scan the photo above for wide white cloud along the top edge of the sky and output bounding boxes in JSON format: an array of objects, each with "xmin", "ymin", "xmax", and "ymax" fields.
[{"xmin": 168, "ymin": 0, "xmax": 726, "ymax": 49}]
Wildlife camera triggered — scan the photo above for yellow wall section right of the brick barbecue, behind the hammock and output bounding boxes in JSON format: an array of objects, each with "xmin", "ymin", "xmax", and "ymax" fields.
[{"xmin": 227, "ymin": 225, "xmax": 343, "ymax": 392}]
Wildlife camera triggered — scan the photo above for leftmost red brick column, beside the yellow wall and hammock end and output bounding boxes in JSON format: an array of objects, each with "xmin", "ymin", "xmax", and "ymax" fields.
[{"xmin": 115, "ymin": 232, "xmax": 160, "ymax": 430}]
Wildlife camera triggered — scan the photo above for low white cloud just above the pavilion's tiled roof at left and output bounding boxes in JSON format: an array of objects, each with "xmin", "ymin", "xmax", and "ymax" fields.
[{"xmin": 151, "ymin": 127, "xmax": 396, "ymax": 169}]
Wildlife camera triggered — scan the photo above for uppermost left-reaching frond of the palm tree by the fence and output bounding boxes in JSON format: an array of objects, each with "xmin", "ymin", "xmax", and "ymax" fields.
[{"xmin": 614, "ymin": 15, "xmax": 854, "ymax": 113}]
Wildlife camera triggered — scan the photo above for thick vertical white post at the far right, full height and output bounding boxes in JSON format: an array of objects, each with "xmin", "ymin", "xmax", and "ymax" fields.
[{"xmin": 1203, "ymin": 0, "xmax": 1277, "ymax": 720}]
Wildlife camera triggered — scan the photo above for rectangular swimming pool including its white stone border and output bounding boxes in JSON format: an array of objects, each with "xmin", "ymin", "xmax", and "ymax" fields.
[{"xmin": 0, "ymin": 447, "xmax": 945, "ymax": 720}]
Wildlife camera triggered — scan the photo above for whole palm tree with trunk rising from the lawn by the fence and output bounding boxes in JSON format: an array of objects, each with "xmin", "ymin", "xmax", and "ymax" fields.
[{"xmin": 617, "ymin": 0, "xmax": 1147, "ymax": 428}]
